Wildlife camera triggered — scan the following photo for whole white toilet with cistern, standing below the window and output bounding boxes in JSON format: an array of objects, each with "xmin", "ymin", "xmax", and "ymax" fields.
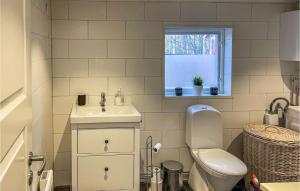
[{"xmin": 185, "ymin": 105, "xmax": 247, "ymax": 191}]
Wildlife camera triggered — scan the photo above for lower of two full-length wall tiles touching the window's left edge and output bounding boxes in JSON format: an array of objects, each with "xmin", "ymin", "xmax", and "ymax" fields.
[{"xmin": 126, "ymin": 59, "xmax": 161, "ymax": 76}]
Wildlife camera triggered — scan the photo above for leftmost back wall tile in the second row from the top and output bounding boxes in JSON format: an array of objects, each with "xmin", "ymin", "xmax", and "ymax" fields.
[{"xmin": 52, "ymin": 20, "xmax": 88, "ymax": 39}]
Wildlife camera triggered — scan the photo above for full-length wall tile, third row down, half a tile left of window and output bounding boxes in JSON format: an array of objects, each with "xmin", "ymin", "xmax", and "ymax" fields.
[{"xmin": 108, "ymin": 40, "xmax": 143, "ymax": 58}]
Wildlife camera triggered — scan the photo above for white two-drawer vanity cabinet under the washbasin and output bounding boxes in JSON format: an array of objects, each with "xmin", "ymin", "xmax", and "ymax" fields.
[{"xmin": 71, "ymin": 104, "xmax": 141, "ymax": 191}]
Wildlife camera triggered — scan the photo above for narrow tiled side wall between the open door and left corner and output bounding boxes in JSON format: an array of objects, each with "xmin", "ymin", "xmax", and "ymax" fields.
[{"xmin": 31, "ymin": 0, "xmax": 53, "ymax": 168}]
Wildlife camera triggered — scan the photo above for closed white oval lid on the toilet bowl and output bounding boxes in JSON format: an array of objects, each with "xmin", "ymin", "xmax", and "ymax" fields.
[{"xmin": 197, "ymin": 149, "xmax": 247, "ymax": 176}]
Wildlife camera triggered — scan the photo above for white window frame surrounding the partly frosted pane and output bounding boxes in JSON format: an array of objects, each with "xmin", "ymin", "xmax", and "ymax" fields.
[{"xmin": 162, "ymin": 25, "xmax": 232, "ymax": 98}]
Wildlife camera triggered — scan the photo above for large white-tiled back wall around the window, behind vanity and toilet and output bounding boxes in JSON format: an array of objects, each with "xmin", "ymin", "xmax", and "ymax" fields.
[{"xmin": 52, "ymin": 0, "xmax": 298, "ymax": 185}]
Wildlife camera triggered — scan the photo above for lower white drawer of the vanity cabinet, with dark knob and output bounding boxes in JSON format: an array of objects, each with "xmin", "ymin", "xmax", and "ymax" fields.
[{"xmin": 78, "ymin": 155, "xmax": 134, "ymax": 191}]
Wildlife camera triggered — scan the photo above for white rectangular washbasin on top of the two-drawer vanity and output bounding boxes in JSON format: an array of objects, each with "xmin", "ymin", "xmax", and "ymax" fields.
[{"xmin": 71, "ymin": 105, "xmax": 141, "ymax": 123}]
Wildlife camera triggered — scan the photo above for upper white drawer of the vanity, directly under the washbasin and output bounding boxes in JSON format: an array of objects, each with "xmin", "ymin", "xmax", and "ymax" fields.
[{"xmin": 78, "ymin": 128, "xmax": 134, "ymax": 153}]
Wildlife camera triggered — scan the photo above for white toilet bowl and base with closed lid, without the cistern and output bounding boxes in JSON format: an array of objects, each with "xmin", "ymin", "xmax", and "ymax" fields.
[{"xmin": 189, "ymin": 149, "xmax": 247, "ymax": 191}]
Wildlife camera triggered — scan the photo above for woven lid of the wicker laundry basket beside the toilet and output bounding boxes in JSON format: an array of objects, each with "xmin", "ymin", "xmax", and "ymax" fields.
[{"xmin": 244, "ymin": 124, "xmax": 300, "ymax": 143}]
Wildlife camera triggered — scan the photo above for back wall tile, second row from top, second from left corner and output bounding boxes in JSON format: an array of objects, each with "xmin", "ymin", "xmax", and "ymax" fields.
[{"xmin": 89, "ymin": 21, "xmax": 125, "ymax": 39}]
